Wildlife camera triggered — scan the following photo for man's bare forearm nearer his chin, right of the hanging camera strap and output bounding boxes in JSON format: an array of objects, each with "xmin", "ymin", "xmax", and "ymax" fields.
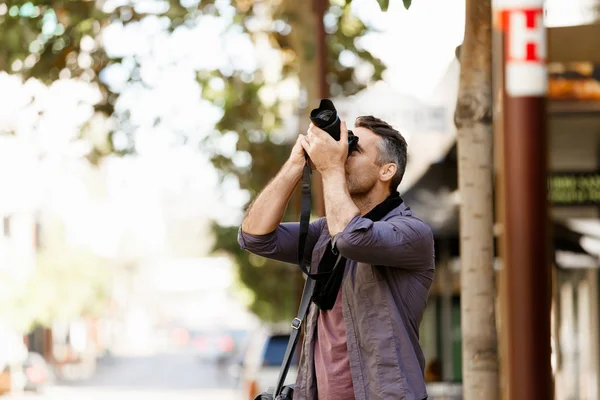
[{"xmin": 322, "ymin": 168, "xmax": 360, "ymax": 237}]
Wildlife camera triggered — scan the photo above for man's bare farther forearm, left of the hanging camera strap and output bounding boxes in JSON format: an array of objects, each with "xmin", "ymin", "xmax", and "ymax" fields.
[{"xmin": 242, "ymin": 162, "xmax": 303, "ymax": 235}]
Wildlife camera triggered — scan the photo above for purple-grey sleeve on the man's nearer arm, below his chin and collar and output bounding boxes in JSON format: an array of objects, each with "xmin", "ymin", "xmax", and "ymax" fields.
[{"xmin": 333, "ymin": 216, "xmax": 434, "ymax": 269}]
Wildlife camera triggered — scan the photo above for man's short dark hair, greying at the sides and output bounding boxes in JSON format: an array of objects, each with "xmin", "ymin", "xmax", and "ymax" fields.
[{"xmin": 354, "ymin": 115, "xmax": 408, "ymax": 193}]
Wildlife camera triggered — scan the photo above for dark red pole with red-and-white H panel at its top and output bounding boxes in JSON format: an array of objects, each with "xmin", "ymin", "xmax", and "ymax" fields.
[{"xmin": 494, "ymin": 0, "xmax": 553, "ymax": 400}]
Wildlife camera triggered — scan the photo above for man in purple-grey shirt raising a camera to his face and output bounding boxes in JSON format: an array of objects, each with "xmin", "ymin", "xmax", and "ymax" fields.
[{"xmin": 238, "ymin": 116, "xmax": 434, "ymax": 400}]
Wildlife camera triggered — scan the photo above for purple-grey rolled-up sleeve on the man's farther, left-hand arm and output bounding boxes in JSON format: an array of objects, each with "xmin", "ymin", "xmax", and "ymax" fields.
[{"xmin": 238, "ymin": 218, "xmax": 325, "ymax": 264}]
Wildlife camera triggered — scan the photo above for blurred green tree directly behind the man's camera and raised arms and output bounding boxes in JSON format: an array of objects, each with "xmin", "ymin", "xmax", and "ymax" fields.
[{"xmin": 204, "ymin": 0, "xmax": 383, "ymax": 321}]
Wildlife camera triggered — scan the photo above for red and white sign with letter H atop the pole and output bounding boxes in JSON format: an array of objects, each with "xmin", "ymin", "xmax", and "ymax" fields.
[{"xmin": 499, "ymin": 0, "xmax": 548, "ymax": 97}]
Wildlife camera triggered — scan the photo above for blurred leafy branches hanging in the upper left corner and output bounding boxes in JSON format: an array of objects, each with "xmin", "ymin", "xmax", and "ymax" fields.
[{"xmin": 0, "ymin": 0, "xmax": 218, "ymax": 163}]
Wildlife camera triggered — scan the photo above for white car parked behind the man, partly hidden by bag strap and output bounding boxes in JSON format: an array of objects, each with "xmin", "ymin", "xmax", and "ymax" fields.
[{"xmin": 240, "ymin": 327, "xmax": 300, "ymax": 400}]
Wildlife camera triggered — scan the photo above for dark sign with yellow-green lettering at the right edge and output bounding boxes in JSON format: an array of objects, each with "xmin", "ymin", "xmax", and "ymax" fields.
[{"xmin": 548, "ymin": 172, "xmax": 600, "ymax": 206}]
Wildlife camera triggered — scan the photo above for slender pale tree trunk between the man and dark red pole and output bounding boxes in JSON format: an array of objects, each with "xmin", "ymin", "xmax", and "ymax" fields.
[{"xmin": 455, "ymin": 0, "xmax": 499, "ymax": 400}]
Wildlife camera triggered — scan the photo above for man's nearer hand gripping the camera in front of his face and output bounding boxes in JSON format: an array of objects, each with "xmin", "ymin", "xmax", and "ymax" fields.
[{"xmin": 299, "ymin": 121, "xmax": 348, "ymax": 173}]
